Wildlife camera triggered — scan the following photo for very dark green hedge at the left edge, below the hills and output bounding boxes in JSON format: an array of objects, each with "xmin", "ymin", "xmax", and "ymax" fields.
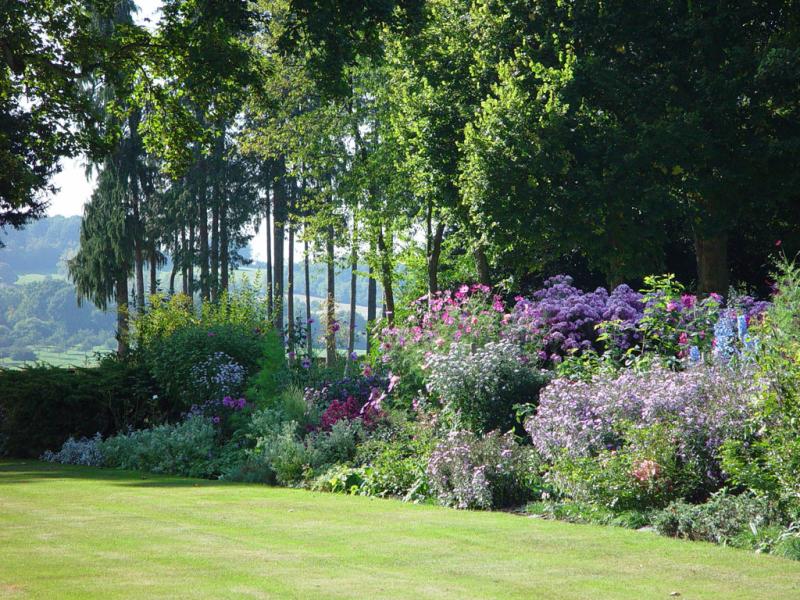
[{"xmin": 0, "ymin": 357, "xmax": 162, "ymax": 457}]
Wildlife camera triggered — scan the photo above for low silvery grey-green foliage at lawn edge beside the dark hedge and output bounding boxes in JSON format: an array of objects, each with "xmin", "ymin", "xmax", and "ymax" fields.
[{"xmin": 100, "ymin": 417, "xmax": 229, "ymax": 478}]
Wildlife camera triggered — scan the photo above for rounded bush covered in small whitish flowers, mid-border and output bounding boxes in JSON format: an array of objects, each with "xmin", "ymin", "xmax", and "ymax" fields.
[{"xmin": 427, "ymin": 340, "xmax": 548, "ymax": 432}]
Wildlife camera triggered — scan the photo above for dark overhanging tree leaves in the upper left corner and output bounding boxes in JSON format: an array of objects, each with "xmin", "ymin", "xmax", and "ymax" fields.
[{"xmin": 0, "ymin": 0, "xmax": 130, "ymax": 230}]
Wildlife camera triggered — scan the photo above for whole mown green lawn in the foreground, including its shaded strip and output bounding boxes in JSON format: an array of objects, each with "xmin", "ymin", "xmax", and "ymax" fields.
[{"xmin": 0, "ymin": 461, "xmax": 800, "ymax": 600}]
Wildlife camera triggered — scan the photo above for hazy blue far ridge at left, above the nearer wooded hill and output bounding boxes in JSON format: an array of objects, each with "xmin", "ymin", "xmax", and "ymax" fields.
[{"xmin": 0, "ymin": 216, "xmax": 81, "ymax": 283}]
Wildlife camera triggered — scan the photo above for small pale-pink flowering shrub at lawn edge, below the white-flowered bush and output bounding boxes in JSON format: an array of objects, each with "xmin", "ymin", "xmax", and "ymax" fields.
[{"xmin": 427, "ymin": 431, "xmax": 539, "ymax": 509}]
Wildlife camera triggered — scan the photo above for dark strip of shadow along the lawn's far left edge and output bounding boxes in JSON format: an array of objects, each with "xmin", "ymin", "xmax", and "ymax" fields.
[{"xmin": 0, "ymin": 459, "xmax": 245, "ymax": 488}]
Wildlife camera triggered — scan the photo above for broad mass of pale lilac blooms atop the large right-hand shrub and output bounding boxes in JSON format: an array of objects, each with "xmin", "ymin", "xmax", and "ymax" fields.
[{"xmin": 525, "ymin": 366, "xmax": 756, "ymax": 468}]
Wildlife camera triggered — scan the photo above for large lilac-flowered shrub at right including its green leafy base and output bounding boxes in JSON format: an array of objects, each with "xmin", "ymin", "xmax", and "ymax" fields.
[{"xmin": 526, "ymin": 365, "xmax": 756, "ymax": 510}]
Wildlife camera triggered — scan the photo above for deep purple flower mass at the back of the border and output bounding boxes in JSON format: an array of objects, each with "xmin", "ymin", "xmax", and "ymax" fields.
[{"xmin": 512, "ymin": 275, "xmax": 644, "ymax": 362}]
